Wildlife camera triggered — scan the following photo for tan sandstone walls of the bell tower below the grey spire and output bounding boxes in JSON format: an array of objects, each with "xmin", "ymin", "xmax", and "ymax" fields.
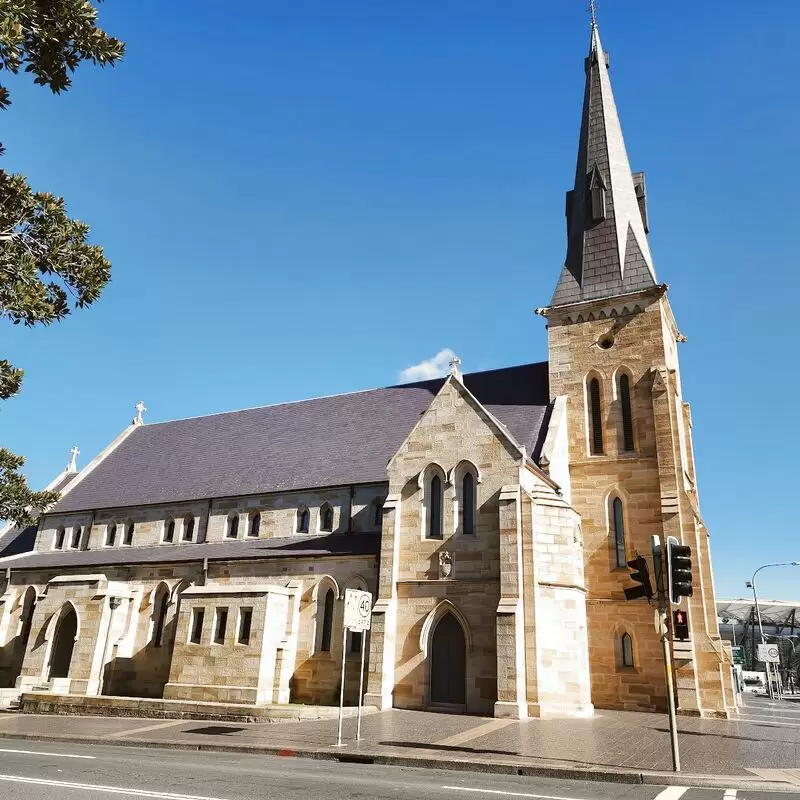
[{"xmin": 548, "ymin": 289, "xmax": 724, "ymax": 713}]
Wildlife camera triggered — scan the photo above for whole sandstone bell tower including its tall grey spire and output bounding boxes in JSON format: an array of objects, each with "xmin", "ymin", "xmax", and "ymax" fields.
[{"xmin": 537, "ymin": 20, "xmax": 734, "ymax": 715}]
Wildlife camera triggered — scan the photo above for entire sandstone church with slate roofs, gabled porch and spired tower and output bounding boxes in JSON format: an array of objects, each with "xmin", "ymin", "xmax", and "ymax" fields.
[{"xmin": 0, "ymin": 17, "xmax": 735, "ymax": 717}]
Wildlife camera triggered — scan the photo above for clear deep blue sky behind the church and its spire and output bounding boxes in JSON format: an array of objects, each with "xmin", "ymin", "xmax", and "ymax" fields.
[{"xmin": 0, "ymin": 0, "xmax": 800, "ymax": 599}]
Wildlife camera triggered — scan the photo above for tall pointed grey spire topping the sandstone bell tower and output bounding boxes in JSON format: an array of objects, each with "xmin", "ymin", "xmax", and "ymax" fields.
[{"xmin": 551, "ymin": 21, "xmax": 656, "ymax": 306}]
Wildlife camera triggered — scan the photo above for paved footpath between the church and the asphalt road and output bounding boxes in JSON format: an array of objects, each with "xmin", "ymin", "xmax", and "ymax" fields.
[{"xmin": 0, "ymin": 699, "xmax": 800, "ymax": 791}]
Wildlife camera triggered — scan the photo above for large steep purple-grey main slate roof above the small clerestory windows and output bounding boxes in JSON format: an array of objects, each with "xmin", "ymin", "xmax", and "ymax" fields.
[{"xmin": 50, "ymin": 362, "xmax": 549, "ymax": 513}]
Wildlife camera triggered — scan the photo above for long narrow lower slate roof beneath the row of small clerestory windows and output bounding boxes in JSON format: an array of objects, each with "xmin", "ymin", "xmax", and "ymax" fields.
[{"xmin": 5, "ymin": 533, "xmax": 380, "ymax": 570}]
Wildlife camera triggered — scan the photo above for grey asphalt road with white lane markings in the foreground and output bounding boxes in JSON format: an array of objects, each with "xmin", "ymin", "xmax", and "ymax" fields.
[{"xmin": 0, "ymin": 740, "xmax": 800, "ymax": 800}]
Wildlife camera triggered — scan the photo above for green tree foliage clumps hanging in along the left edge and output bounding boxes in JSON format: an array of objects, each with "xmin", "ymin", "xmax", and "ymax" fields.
[{"xmin": 0, "ymin": 0, "xmax": 125, "ymax": 524}]
